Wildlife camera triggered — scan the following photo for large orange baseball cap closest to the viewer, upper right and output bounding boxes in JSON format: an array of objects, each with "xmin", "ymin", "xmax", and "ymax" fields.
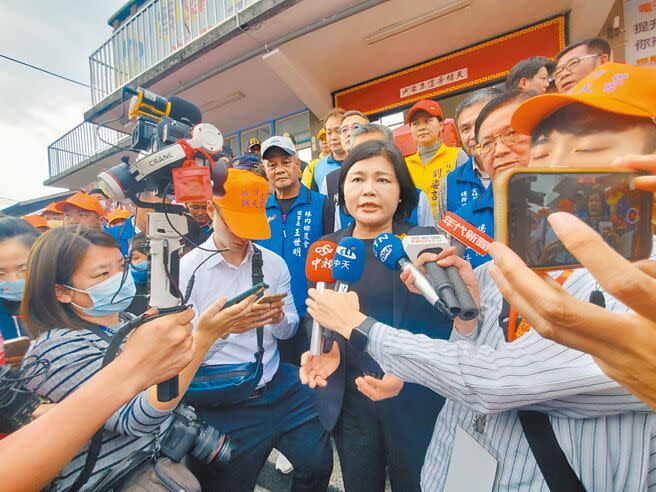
[{"xmin": 512, "ymin": 63, "xmax": 656, "ymax": 135}]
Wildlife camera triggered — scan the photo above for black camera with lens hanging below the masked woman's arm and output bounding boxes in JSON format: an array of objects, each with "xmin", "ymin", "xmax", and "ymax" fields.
[{"xmin": 160, "ymin": 405, "xmax": 232, "ymax": 464}]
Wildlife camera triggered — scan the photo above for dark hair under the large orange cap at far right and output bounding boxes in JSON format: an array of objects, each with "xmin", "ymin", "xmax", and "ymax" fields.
[{"xmin": 531, "ymin": 103, "xmax": 656, "ymax": 154}]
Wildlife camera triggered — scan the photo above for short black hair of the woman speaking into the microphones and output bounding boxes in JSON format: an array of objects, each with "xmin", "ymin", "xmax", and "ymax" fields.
[{"xmin": 338, "ymin": 140, "xmax": 419, "ymax": 221}]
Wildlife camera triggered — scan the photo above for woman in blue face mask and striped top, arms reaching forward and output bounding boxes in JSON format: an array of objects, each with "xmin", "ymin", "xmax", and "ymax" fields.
[{"xmin": 22, "ymin": 227, "xmax": 264, "ymax": 491}]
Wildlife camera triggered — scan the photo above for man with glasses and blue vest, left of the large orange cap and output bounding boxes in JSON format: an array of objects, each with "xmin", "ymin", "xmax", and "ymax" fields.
[{"xmin": 457, "ymin": 89, "xmax": 537, "ymax": 268}]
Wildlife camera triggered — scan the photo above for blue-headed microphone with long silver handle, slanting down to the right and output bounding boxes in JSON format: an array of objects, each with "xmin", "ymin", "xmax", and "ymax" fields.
[{"xmin": 373, "ymin": 232, "xmax": 450, "ymax": 316}]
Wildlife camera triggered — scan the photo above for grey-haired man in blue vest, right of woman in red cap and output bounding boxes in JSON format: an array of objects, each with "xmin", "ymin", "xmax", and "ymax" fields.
[{"xmin": 435, "ymin": 87, "xmax": 501, "ymax": 220}]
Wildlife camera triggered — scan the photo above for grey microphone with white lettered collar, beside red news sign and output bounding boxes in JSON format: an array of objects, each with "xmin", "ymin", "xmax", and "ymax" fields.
[{"xmin": 403, "ymin": 227, "xmax": 478, "ymax": 321}]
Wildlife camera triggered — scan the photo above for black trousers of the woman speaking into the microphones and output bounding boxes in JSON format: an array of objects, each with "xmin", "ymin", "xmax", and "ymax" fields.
[{"xmin": 333, "ymin": 378, "xmax": 444, "ymax": 492}]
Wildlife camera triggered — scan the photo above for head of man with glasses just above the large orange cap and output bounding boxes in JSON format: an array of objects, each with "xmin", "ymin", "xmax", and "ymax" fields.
[{"xmin": 553, "ymin": 38, "xmax": 610, "ymax": 93}]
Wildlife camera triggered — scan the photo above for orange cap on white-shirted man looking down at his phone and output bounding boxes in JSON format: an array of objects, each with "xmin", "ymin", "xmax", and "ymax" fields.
[{"xmin": 213, "ymin": 168, "xmax": 271, "ymax": 239}]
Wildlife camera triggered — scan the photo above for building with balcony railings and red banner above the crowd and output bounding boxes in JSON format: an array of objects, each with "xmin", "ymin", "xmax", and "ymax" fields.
[{"xmin": 45, "ymin": 0, "xmax": 624, "ymax": 188}]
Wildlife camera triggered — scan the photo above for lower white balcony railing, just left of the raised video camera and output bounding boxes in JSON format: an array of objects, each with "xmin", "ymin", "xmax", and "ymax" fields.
[{"xmin": 48, "ymin": 121, "xmax": 130, "ymax": 178}]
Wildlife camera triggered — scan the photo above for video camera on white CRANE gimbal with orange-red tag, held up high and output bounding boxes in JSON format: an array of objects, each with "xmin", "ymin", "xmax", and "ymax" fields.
[{"xmin": 98, "ymin": 88, "xmax": 228, "ymax": 401}]
